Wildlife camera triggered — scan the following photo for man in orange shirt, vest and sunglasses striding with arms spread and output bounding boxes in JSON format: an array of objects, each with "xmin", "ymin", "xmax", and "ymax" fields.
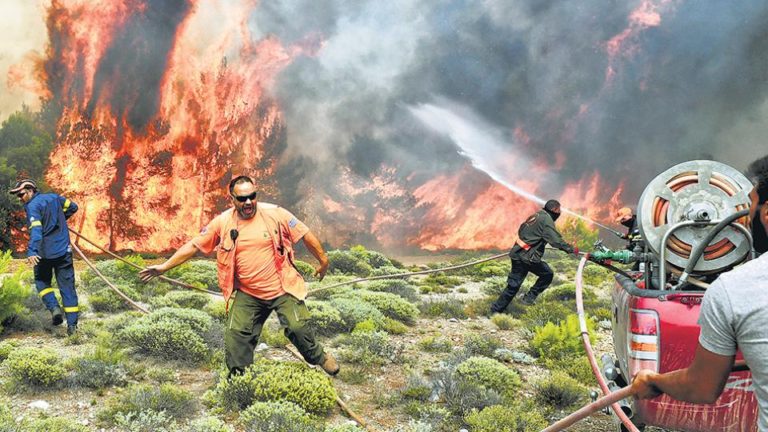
[{"xmin": 140, "ymin": 176, "xmax": 339, "ymax": 376}]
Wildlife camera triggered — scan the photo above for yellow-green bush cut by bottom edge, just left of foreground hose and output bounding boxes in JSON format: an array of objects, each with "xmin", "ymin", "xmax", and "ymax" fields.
[{"xmin": 464, "ymin": 405, "xmax": 548, "ymax": 432}]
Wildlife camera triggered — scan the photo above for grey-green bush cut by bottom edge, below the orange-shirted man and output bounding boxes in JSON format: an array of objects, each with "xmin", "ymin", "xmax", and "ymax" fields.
[{"xmin": 239, "ymin": 401, "xmax": 324, "ymax": 432}]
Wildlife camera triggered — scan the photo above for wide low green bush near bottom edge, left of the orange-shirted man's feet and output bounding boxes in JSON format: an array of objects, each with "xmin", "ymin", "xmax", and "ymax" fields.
[{"xmin": 98, "ymin": 384, "xmax": 197, "ymax": 423}]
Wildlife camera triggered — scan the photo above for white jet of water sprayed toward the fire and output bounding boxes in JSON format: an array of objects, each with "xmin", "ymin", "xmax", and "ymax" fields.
[{"xmin": 408, "ymin": 104, "xmax": 617, "ymax": 233}]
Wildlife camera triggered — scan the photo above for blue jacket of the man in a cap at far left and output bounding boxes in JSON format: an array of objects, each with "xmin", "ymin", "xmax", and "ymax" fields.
[{"xmin": 24, "ymin": 192, "xmax": 77, "ymax": 259}]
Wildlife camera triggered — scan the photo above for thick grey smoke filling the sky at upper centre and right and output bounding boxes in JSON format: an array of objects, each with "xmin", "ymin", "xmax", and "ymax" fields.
[{"xmin": 252, "ymin": 0, "xmax": 768, "ymax": 201}]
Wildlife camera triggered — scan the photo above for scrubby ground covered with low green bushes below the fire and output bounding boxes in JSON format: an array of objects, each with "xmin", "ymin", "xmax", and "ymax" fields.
[{"xmin": 0, "ymin": 246, "xmax": 624, "ymax": 432}]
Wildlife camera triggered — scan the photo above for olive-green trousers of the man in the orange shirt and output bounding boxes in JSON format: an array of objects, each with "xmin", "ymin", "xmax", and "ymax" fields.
[{"xmin": 224, "ymin": 291, "xmax": 325, "ymax": 372}]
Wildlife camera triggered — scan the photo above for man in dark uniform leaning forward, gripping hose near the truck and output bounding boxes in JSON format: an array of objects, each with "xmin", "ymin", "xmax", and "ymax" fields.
[{"xmin": 491, "ymin": 200, "xmax": 579, "ymax": 313}]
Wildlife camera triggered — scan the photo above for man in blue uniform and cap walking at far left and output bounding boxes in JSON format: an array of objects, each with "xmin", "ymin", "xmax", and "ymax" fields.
[{"xmin": 9, "ymin": 179, "xmax": 79, "ymax": 335}]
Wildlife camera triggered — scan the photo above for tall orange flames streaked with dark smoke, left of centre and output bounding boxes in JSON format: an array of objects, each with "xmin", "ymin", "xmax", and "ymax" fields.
[{"xmin": 46, "ymin": 0, "xmax": 301, "ymax": 250}]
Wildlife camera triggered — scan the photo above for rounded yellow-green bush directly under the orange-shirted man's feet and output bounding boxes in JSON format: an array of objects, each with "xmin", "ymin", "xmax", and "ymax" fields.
[{"xmin": 205, "ymin": 358, "xmax": 336, "ymax": 415}]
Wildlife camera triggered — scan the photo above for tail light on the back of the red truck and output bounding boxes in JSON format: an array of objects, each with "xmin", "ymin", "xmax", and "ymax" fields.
[{"xmin": 627, "ymin": 309, "xmax": 659, "ymax": 376}]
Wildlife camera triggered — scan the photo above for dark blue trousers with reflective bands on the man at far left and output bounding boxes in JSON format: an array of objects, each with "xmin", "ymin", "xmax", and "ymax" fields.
[{"xmin": 34, "ymin": 252, "xmax": 80, "ymax": 326}]
